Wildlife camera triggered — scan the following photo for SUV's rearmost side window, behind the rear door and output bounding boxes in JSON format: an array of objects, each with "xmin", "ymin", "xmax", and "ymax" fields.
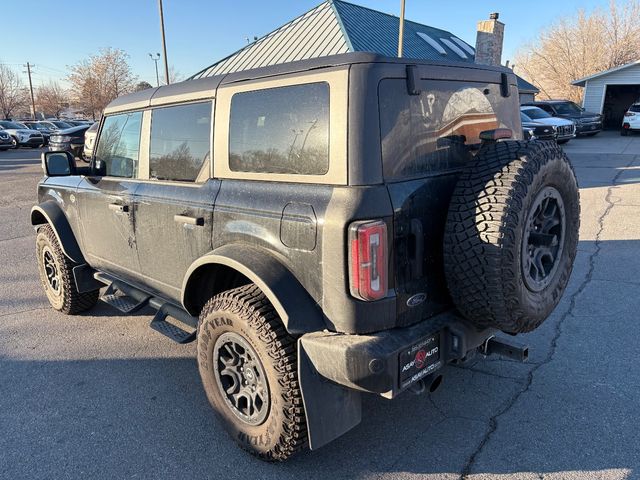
[{"xmin": 229, "ymin": 83, "xmax": 329, "ymax": 175}]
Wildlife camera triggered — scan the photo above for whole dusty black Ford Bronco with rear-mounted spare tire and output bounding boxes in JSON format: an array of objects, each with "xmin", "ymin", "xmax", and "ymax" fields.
[{"xmin": 31, "ymin": 53, "xmax": 580, "ymax": 460}]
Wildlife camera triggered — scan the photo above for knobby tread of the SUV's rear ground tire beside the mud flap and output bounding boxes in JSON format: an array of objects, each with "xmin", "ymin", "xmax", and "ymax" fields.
[{"xmin": 198, "ymin": 284, "xmax": 308, "ymax": 462}]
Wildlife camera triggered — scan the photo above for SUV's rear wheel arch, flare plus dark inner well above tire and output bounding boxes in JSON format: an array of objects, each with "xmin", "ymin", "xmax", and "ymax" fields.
[{"xmin": 182, "ymin": 245, "xmax": 326, "ymax": 334}]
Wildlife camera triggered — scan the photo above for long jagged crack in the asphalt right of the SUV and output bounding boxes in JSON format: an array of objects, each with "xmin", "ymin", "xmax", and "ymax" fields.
[{"xmin": 459, "ymin": 157, "xmax": 639, "ymax": 480}]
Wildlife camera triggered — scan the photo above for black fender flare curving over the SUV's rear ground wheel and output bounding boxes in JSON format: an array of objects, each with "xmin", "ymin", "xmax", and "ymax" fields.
[{"xmin": 181, "ymin": 244, "xmax": 327, "ymax": 335}]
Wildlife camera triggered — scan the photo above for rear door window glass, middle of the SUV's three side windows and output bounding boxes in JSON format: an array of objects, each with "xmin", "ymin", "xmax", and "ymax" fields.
[{"xmin": 149, "ymin": 102, "xmax": 211, "ymax": 182}]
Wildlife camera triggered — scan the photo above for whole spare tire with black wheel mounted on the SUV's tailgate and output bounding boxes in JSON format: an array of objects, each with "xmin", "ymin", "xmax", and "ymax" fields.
[{"xmin": 444, "ymin": 141, "xmax": 580, "ymax": 334}]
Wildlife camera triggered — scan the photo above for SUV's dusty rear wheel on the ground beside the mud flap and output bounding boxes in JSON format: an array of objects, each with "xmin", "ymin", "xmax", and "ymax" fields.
[{"xmin": 198, "ymin": 284, "xmax": 307, "ymax": 461}]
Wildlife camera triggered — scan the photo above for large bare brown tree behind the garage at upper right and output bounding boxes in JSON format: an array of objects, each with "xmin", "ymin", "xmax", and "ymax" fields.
[{"xmin": 515, "ymin": 0, "xmax": 640, "ymax": 101}]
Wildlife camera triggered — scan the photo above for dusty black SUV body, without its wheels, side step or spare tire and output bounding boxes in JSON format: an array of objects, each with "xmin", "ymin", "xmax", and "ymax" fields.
[{"xmin": 32, "ymin": 53, "xmax": 536, "ymax": 454}]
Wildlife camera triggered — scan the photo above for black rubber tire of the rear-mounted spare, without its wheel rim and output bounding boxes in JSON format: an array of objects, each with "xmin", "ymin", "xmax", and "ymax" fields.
[{"xmin": 444, "ymin": 141, "xmax": 579, "ymax": 333}]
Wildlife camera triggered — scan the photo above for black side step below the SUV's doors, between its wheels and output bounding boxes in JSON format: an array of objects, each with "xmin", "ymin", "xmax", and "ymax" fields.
[{"xmin": 94, "ymin": 272, "xmax": 198, "ymax": 343}]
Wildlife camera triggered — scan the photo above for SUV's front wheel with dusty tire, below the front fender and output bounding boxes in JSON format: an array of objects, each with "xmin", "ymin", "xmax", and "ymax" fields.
[{"xmin": 36, "ymin": 225, "xmax": 99, "ymax": 315}]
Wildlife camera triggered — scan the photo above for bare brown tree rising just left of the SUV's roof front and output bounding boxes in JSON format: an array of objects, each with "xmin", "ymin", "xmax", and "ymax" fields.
[{"xmin": 67, "ymin": 48, "xmax": 137, "ymax": 119}]
